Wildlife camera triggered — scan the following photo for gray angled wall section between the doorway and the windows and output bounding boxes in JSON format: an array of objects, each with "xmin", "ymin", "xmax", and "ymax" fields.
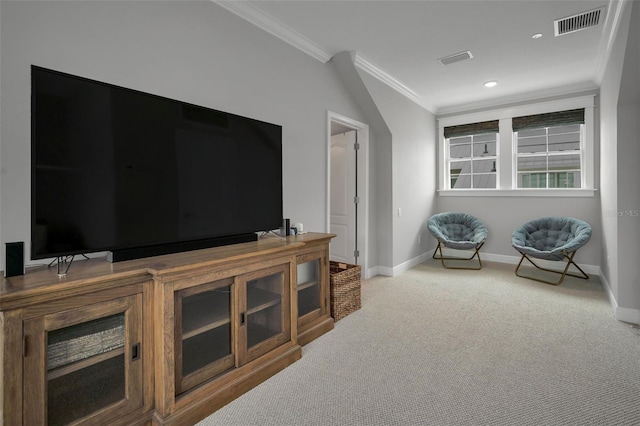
[{"xmin": 331, "ymin": 52, "xmax": 436, "ymax": 275}]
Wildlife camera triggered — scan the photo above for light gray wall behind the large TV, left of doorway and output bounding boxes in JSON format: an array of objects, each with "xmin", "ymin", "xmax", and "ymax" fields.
[{"xmin": 0, "ymin": 1, "xmax": 365, "ymax": 269}]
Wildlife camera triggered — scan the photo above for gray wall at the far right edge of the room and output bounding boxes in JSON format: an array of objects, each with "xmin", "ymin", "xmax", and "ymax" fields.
[{"xmin": 600, "ymin": 2, "xmax": 640, "ymax": 323}]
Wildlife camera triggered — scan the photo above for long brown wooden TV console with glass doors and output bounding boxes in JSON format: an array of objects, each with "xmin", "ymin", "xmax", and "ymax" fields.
[{"xmin": 0, "ymin": 233, "xmax": 334, "ymax": 425}]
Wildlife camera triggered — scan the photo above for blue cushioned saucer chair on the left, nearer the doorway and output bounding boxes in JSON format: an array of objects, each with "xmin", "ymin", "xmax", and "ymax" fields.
[{"xmin": 427, "ymin": 212, "xmax": 487, "ymax": 269}]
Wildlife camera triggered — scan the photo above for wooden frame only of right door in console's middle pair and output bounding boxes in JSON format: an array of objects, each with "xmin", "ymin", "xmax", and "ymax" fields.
[{"xmin": 236, "ymin": 262, "xmax": 291, "ymax": 365}]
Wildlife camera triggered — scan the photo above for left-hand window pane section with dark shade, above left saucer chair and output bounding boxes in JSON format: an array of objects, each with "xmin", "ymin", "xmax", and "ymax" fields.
[{"xmin": 445, "ymin": 120, "xmax": 498, "ymax": 189}]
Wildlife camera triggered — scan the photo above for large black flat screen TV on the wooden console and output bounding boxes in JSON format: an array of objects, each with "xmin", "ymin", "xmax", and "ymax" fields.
[{"xmin": 31, "ymin": 66, "xmax": 283, "ymax": 261}]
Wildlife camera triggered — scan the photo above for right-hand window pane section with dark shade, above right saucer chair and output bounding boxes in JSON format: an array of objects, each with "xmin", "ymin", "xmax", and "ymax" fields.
[{"xmin": 512, "ymin": 109, "xmax": 584, "ymax": 188}]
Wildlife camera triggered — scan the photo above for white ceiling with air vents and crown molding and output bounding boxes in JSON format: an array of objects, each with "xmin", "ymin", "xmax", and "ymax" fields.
[{"xmin": 214, "ymin": 0, "xmax": 619, "ymax": 114}]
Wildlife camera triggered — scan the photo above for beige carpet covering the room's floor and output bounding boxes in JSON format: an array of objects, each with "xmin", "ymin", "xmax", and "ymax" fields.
[{"xmin": 199, "ymin": 259, "xmax": 640, "ymax": 426}]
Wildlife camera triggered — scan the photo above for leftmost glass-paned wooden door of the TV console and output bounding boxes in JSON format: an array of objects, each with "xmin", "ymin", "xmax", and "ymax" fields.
[{"xmin": 24, "ymin": 295, "xmax": 142, "ymax": 425}]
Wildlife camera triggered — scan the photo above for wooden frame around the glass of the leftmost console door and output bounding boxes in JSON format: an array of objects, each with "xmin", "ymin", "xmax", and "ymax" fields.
[{"xmin": 23, "ymin": 293, "xmax": 146, "ymax": 425}]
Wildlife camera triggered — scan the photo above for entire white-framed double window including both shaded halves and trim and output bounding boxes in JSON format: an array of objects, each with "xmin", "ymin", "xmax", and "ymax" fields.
[{"xmin": 438, "ymin": 95, "xmax": 595, "ymax": 197}]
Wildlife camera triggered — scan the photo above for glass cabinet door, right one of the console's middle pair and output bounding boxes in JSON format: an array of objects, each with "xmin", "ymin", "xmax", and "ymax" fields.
[{"xmin": 240, "ymin": 264, "xmax": 291, "ymax": 362}]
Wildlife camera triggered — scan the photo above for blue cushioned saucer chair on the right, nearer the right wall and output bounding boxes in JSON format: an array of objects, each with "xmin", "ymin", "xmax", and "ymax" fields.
[{"xmin": 511, "ymin": 217, "xmax": 591, "ymax": 285}]
